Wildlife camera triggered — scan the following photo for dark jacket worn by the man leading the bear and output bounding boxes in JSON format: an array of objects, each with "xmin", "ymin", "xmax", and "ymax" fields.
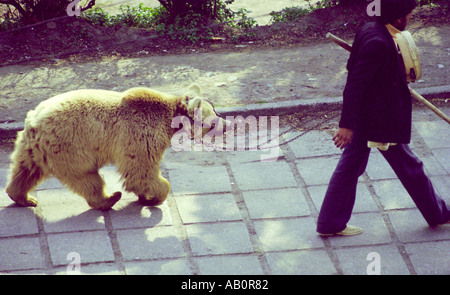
[{"xmin": 339, "ymin": 22, "xmax": 412, "ymax": 143}]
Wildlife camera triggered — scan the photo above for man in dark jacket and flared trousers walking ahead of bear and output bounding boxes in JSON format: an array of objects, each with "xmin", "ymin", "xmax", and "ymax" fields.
[{"xmin": 317, "ymin": 0, "xmax": 450, "ymax": 236}]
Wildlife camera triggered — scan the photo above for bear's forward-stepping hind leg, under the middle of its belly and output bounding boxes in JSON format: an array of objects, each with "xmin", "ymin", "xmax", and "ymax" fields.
[{"xmin": 57, "ymin": 171, "xmax": 122, "ymax": 210}]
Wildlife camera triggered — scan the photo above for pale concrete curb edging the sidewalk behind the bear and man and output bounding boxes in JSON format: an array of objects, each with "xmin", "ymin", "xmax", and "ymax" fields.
[{"xmin": 0, "ymin": 85, "xmax": 450, "ymax": 132}]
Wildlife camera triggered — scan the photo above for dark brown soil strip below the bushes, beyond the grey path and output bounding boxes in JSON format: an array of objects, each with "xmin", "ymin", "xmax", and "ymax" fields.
[{"xmin": 0, "ymin": 1, "xmax": 449, "ymax": 66}]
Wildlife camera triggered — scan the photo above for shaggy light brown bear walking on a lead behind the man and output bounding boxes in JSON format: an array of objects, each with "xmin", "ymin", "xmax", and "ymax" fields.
[{"xmin": 6, "ymin": 85, "xmax": 220, "ymax": 210}]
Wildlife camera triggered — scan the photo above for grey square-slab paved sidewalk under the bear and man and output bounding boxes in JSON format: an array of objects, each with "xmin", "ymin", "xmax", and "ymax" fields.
[{"xmin": 0, "ymin": 109, "xmax": 450, "ymax": 275}]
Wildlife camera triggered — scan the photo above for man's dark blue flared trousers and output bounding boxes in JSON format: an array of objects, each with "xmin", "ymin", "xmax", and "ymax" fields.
[{"xmin": 317, "ymin": 132, "xmax": 450, "ymax": 234}]
